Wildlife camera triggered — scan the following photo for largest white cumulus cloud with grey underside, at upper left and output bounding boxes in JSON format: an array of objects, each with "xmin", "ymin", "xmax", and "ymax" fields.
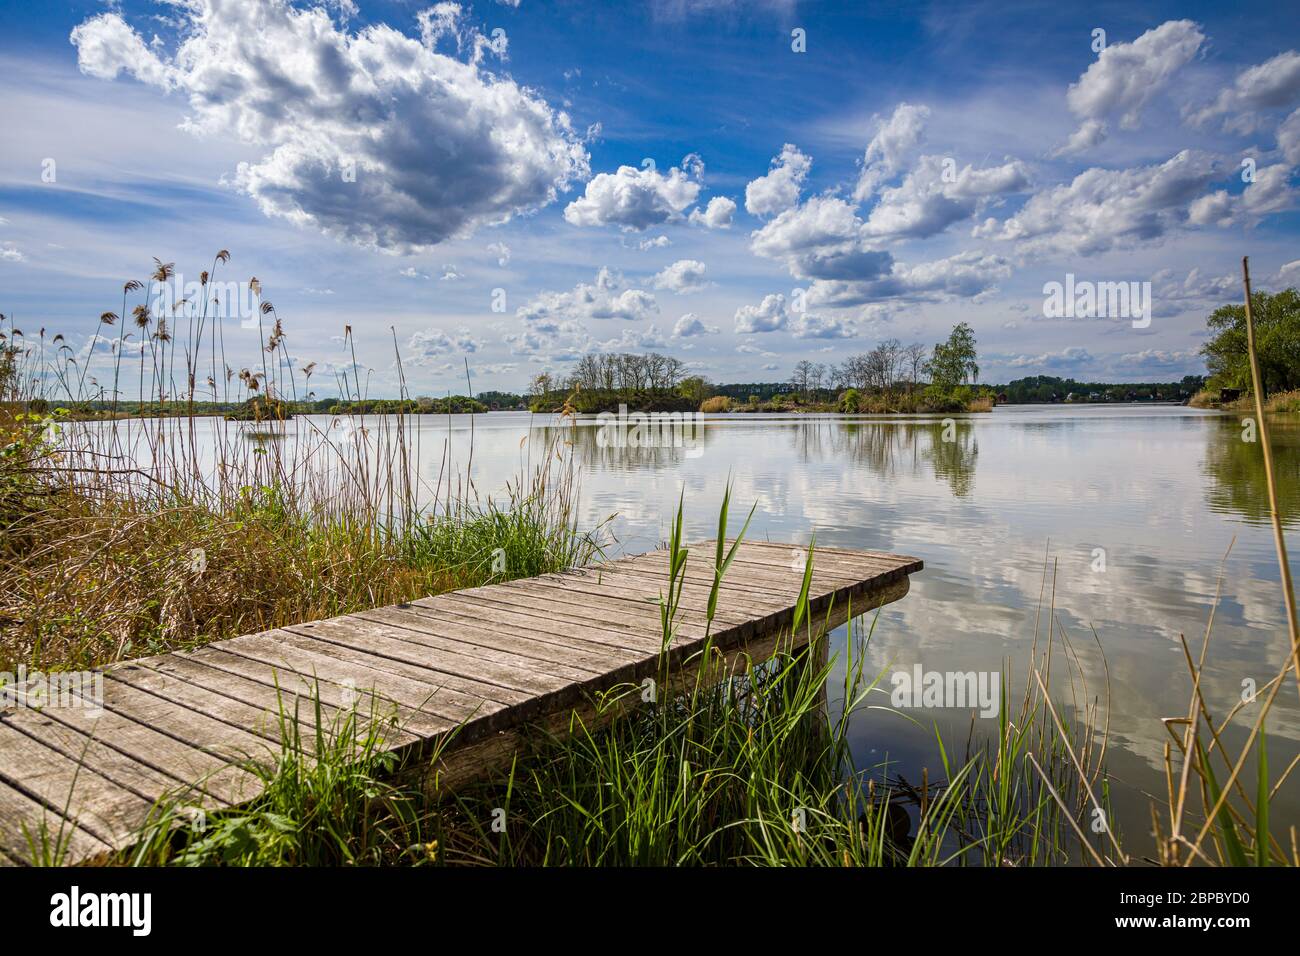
[{"xmin": 70, "ymin": 0, "xmax": 589, "ymax": 252}]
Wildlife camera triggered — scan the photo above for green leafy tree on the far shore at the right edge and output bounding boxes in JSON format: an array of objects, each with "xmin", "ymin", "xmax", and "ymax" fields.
[{"xmin": 1201, "ymin": 289, "xmax": 1300, "ymax": 395}]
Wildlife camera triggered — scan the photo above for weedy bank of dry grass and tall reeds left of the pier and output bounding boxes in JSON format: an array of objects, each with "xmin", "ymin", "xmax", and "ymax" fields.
[{"xmin": 0, "ymin": 251, "xmax": 601, "ymax": 671}]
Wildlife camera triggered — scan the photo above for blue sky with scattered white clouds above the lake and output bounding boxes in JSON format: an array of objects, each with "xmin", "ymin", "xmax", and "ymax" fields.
[{"xmin": 0, "ymin": 0, "xmax": 1300, "ymax": 394}]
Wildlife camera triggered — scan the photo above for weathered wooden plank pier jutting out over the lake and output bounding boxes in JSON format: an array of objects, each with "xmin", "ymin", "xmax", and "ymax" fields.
[{"xmin": 0, "ymin": 541, "xmax": 922, "ymax": 864}]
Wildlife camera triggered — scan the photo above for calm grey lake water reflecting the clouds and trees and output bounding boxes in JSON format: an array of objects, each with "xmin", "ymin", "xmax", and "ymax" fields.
[{"xmin": 94, "ymin": 406, "xmax": 1300, "ymax": 851}]
